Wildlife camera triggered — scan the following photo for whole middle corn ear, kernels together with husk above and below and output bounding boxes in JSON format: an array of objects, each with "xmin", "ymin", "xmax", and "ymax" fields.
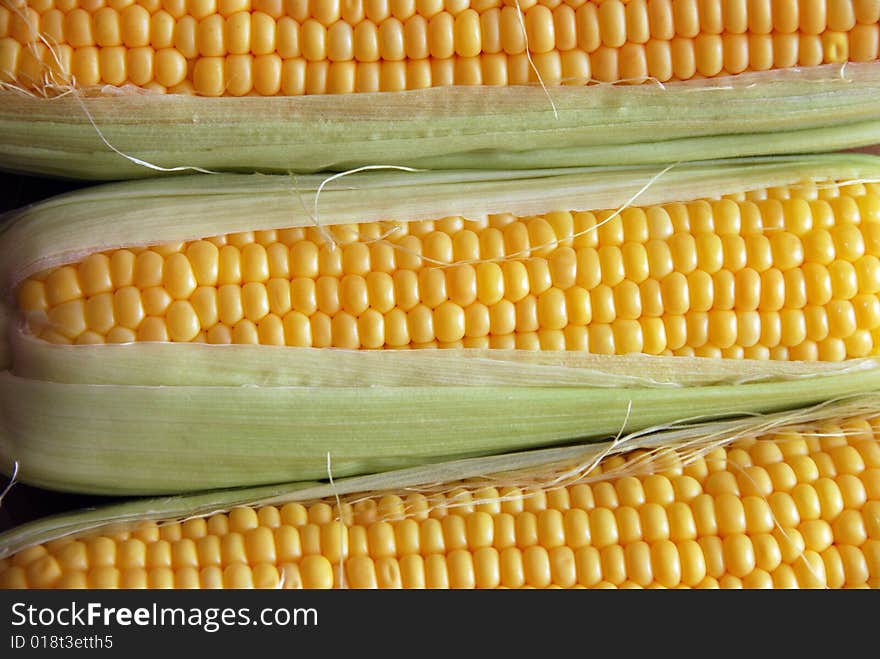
[{"xmin": 0, "ymin": 156, "xmax": 878, "ymax": 494}]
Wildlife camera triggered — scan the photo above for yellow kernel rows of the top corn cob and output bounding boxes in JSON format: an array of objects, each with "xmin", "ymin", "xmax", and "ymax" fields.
[{"xmin": 0, "ymin": 0, "xmax": 880, "ymax": 96}]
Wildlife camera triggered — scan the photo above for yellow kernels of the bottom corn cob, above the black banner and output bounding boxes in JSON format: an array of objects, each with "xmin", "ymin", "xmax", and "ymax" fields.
[{"xmin": 0, "ymin": 418, "xmax": 880, "ymax": 588}]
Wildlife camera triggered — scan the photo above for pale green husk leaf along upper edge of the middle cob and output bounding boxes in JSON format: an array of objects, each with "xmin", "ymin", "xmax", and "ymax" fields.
[{"xmin": 0, "ymin": 153, "xmax": 880, "ymax": 286}]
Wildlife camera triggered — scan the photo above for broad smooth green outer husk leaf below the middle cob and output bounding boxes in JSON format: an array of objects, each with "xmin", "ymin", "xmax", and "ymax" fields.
[{"xmin": 0, "ymin": 368, "xmax": 880, "ymax": 494}]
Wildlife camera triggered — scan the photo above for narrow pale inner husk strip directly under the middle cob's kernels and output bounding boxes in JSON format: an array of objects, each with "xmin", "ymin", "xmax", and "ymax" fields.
[{"xmin": 11, "ymin": 332, "xmax": 880, "ymax": 388}]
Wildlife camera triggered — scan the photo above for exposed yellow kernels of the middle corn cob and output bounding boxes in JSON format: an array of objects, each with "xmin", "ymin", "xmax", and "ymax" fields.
[{"xmin": 19, "ymin": 184, "xmax": 880, "ymax": 361}]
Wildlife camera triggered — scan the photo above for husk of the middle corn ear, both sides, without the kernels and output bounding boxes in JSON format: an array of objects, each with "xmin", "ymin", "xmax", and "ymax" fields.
[{"xmin": 0, "ymin": 155, "xmax": 880, "ymax": 494}]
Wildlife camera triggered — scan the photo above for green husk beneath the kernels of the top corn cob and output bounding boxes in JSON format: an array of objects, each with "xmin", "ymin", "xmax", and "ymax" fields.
[{"xmin": 0, "ymin": 62, "xmax": 880, "ymax": 179}]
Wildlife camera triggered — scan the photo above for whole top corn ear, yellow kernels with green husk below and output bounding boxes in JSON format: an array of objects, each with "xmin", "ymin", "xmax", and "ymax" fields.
[{"xmin": 0, "ymin": 0, "xmax": 880, "ymax": 179}]
